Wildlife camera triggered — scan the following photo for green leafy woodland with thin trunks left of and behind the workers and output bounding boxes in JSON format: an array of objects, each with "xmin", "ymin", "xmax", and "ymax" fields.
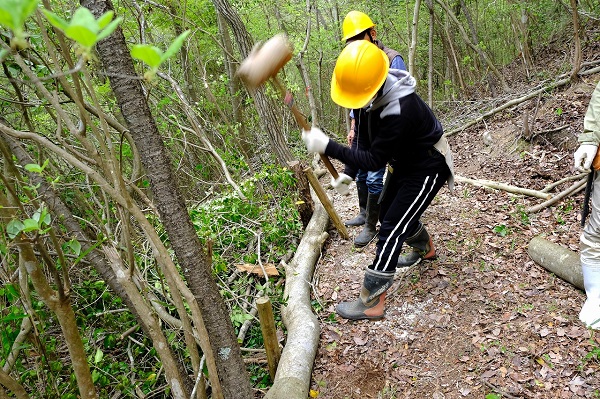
[{"xmin": 0, "ymin": 0, "xmax": 600, "ymax": 398}]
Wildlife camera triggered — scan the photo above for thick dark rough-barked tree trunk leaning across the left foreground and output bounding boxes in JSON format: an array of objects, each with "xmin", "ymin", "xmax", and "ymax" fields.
[{"xmin": 81, "ymin": 0, "xmax": 253, "ymax": 398}]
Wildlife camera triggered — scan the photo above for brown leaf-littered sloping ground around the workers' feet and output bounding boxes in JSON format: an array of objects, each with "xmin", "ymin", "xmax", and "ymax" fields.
[{"xmin": 311, "ymin": 65, "xmax": 600, "ymax": 399}]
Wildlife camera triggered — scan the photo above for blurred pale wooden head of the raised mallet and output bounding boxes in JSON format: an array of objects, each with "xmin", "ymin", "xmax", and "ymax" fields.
[{"xmin": 237, "ymin": 33, "xmax": 292, "ymax": 89}]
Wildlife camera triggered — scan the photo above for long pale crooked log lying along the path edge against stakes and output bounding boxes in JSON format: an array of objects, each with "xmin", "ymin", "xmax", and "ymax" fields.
[{"xmin": 265, "ymin": 193, "xmax": 329, "ymax": 399}]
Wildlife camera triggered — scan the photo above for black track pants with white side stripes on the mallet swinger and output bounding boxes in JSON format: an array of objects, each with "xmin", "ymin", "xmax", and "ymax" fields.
[{"xmin": 369, "ymin": 165, "xmax": 450, "ymax": 273}]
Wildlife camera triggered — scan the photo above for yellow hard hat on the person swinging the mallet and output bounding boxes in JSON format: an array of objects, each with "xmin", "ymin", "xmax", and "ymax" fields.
[{"xmin": 331, "ymin": 40, "xmax": 390, "ymax": 109}]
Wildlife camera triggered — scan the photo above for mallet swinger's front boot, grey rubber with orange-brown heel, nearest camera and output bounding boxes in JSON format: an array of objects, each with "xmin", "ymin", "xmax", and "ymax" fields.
[{"xmin": 335, "ymin": 269, "xmax": 394, "ymax": 320}]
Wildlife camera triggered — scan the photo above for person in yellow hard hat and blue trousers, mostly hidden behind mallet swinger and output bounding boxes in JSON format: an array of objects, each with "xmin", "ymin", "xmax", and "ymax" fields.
[{"xmin": 342, "ymin": 11, "xmax": 406, "ymax": 247}]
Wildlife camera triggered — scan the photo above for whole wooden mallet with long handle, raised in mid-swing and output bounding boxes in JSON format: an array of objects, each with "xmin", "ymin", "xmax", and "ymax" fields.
[{"xmin": 237, "ymin": 34, "xmax": 339, "ymax": 179}]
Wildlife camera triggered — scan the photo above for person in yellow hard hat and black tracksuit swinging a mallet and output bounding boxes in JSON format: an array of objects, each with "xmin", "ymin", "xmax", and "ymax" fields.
[{"xmin": 302, "ymin": 40, "xmax": 454, "ymax": 320}]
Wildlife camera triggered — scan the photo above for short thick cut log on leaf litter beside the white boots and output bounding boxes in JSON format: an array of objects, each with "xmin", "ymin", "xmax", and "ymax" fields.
[{"xmin": 527, "ymin": 236, "xmax": 584, "ymax": 290}]
